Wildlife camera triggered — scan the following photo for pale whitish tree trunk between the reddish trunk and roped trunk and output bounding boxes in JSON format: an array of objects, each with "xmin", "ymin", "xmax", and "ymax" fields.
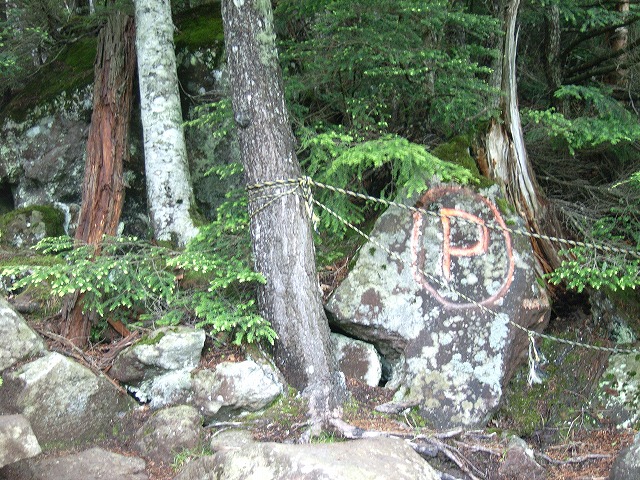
[{"xmin": 135, "ymin": 0, "xmax": 198, "ymax": 246}]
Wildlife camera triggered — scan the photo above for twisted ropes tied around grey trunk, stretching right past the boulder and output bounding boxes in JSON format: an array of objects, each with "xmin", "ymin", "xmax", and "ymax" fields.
[{"xmin": 247, "ymin": 177, "xmax": 640, "ymax": 372}]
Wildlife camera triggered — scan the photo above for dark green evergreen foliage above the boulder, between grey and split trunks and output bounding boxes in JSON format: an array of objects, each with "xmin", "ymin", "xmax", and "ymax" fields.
[{"xmin": 276, "ymin": 0, "xmax": 498, "ymax": 140}]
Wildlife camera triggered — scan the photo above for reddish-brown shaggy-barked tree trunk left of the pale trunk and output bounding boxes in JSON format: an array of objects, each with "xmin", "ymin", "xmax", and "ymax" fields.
[{"xmin": 62, "ymin": 13, "xmax": 135, "ymax": 346}]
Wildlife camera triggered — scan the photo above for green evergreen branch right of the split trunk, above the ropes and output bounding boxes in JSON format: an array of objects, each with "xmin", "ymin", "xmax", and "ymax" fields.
[{"xmin": 523, "ymin": 85, "xmax": 640, "ymax": 155}]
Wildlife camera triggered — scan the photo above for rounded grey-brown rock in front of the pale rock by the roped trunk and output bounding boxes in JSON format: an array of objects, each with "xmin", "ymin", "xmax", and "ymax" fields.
[{"xmin": 134, "ymin": 405, "xmax": 204, "ymax": 464}]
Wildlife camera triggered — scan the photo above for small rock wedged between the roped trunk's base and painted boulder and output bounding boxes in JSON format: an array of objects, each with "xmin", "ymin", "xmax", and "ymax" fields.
[{"xmin": 331, "ymin": 333, "xmax": 382, "ymax": 387}]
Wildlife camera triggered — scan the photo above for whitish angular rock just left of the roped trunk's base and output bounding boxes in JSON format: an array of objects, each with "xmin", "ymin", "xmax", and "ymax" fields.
[{"xmin": 193, "ymin": 360, "xmax": 284, "ymax": 421}]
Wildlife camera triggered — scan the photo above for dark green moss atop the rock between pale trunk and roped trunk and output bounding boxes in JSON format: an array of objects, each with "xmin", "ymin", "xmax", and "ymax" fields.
[{"xmin": 174, "ymin": 2, "xmax": 224, "ymax": 50}]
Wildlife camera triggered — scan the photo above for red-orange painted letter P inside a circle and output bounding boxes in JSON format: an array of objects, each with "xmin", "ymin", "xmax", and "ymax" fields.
[{"xmin": 411, "ymin": 187, "xmax": 515, "ymax": 309}]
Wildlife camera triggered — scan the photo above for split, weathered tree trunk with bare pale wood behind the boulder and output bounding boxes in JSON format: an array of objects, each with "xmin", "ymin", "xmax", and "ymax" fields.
[{"xmin": 478, "ymin": 0, "xmax": 561, "ymax": 273}]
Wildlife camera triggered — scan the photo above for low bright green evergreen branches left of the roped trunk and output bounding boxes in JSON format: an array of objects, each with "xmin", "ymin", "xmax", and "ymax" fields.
[{"xmin": 0, "ymin": 169, "xmax": 276, "ymax": 344}]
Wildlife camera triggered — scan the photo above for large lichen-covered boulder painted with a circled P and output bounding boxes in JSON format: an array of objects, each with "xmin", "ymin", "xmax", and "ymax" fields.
[{"xmin": 327, "ymin": 185, "xmax": 549, "ymax": 428}]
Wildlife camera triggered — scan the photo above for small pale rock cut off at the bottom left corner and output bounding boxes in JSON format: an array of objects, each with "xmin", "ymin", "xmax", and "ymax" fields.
[{"xmin": 0, "ymin": 415, "xmax": 42, "ymax": 468}]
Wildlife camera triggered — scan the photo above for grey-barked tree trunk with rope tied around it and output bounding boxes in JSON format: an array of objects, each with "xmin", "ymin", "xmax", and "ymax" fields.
[{"xmin": 222, "ymin": 0, "xmax": 344, "ymax": 423}]
